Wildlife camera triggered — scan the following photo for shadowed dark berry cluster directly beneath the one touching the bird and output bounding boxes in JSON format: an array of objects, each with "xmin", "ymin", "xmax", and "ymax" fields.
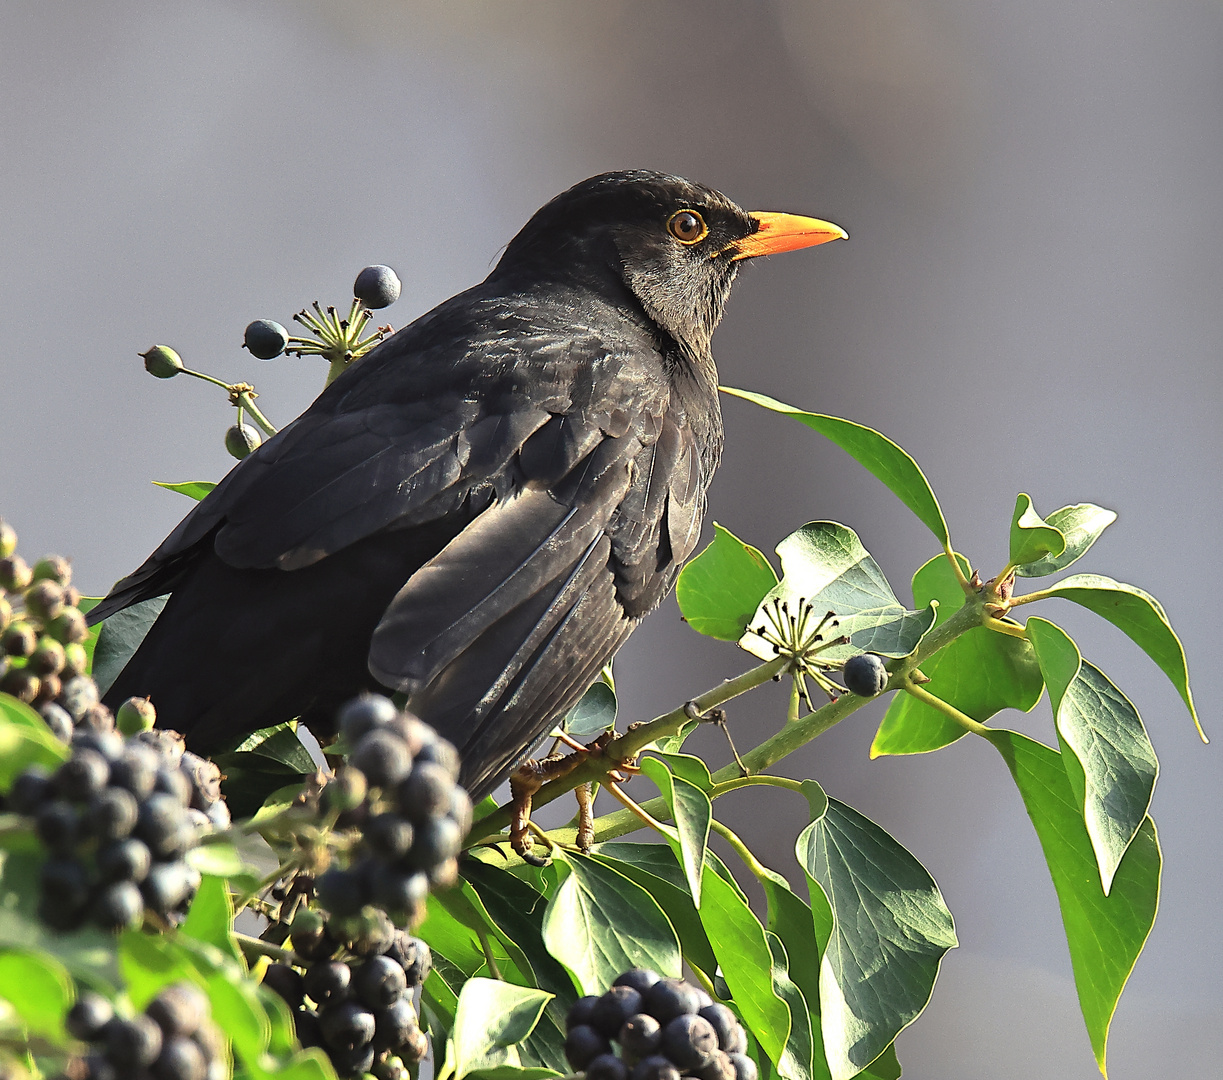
[{"xmin": 263, "ymin": 911, "xmax": 433, "ymax": 1080}]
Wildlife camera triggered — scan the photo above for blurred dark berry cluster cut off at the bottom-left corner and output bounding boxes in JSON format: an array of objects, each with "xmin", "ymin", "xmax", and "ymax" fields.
[{"xmin": 64, "ymin": 982, "xmax": 229, "ymax": 1080}]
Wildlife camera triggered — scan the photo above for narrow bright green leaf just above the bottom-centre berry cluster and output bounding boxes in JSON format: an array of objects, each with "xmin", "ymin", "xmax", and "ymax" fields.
[{"xmin": 701, "ymin": 873, "xmax": 790, "ymax": 1064}]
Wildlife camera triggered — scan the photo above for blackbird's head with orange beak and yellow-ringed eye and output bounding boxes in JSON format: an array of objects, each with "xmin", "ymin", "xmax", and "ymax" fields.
[{"xmin": 493, "ymin": 171, "xmax": 846, "ymax": 356}]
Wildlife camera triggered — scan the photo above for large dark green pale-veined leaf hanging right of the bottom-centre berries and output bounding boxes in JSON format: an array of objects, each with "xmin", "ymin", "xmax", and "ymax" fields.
[{"xmin": 799, "ymin": 799, "xmax": 958, "ymax": 1080}]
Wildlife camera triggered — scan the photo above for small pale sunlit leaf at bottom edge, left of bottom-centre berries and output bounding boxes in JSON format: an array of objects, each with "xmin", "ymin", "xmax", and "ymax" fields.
[{"xmin": 451, "ymin": 978, "xmax": 558, "ymax": 1080}]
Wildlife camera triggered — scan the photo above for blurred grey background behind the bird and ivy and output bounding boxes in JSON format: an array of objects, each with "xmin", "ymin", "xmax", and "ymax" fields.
[{"xmin": 0, "ymin": 0, "xmax": 1223, "ymax": 1080}]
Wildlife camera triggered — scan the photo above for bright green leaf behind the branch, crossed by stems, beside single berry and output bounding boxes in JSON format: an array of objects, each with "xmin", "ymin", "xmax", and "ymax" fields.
[{"xmin": 871, "ymin": 555, "xmax": 1044, "ymax": 757}]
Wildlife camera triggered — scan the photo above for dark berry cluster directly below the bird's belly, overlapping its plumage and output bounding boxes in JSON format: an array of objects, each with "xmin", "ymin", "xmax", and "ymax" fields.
[{"xmin": 308, "ymin": 693, "xmax": 471, "ymax": 926}]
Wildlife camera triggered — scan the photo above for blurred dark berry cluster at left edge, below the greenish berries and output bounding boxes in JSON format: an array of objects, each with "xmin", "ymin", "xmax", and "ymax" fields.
[{"xmin": 5, "ymin": 729, "xmax": 230, "ymax": 931}]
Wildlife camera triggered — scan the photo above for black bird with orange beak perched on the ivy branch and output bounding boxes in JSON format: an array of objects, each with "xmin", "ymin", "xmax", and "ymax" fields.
[{"xmin": 91, "ymin": 171, "xmax": 845, "ymax": 799}]
